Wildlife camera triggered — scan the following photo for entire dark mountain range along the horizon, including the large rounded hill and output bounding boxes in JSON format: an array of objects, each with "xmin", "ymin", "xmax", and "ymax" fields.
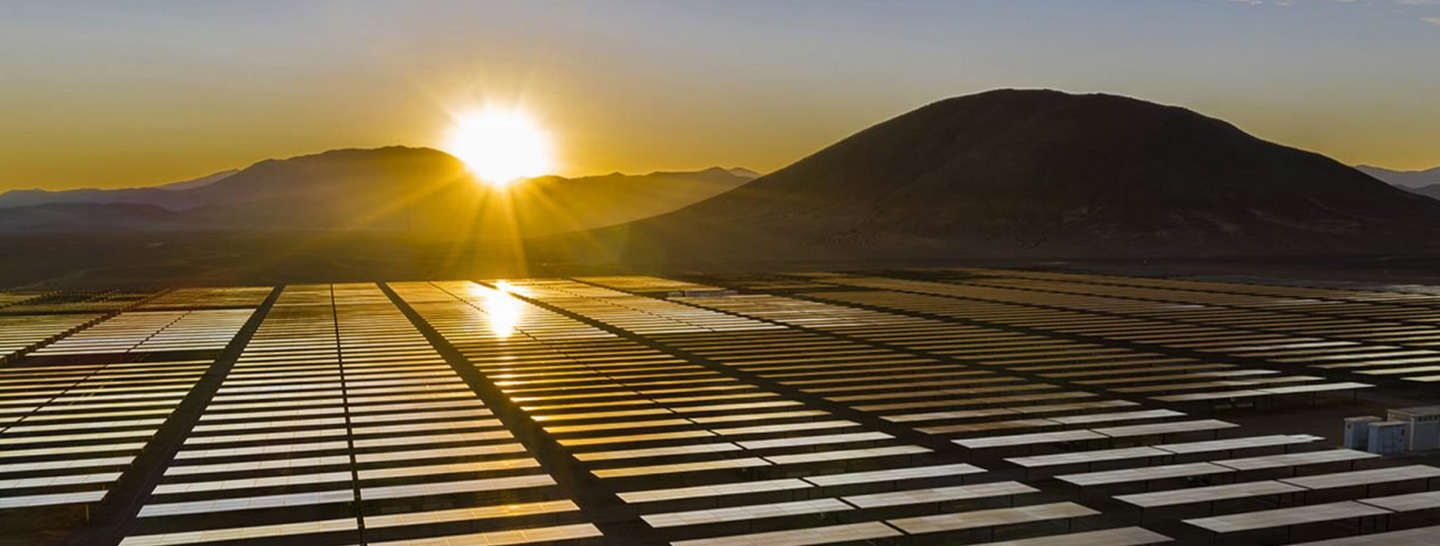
[{"xmin": 11, "ymin": 89, "xmax": 1440, "ymax": 267}]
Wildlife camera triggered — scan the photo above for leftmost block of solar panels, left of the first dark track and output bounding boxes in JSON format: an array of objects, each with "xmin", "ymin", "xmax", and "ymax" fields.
[{"xmin": 0, "ymin": 283, "xmax": 258, "ymax": 541}]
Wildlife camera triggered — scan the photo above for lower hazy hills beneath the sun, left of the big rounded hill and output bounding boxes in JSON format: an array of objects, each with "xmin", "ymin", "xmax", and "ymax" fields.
[{"xmin": 0, "ymin": 147, "xmax": 756, "ymax": 238}]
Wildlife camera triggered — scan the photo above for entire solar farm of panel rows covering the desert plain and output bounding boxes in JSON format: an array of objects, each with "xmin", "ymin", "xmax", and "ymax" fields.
[{"xmin": 0, "ymin": 273, "xmax": 1440, "ymax": 546}]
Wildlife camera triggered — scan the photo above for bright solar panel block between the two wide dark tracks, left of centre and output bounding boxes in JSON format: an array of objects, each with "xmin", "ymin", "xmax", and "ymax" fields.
[{"xmin": 122, "ymin": 284, "xmax": 593, "ymax": 546}]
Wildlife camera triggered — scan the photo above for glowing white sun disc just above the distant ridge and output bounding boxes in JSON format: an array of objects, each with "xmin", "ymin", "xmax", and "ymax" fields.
[{"xmin": 445, "ymin": 107, "xmax": 553, "ymax": 187}]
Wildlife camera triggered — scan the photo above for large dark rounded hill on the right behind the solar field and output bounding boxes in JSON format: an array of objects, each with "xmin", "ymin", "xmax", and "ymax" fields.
[{"xmin": 604, "ymin": 89, "xmax": 1440, "ymax": 262}]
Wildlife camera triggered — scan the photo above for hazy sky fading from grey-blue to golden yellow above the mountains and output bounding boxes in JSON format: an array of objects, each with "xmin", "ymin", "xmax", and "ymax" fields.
[{"xmin": 0, "ymin": 0, "xmax": 1440, "ymax": 192}]
